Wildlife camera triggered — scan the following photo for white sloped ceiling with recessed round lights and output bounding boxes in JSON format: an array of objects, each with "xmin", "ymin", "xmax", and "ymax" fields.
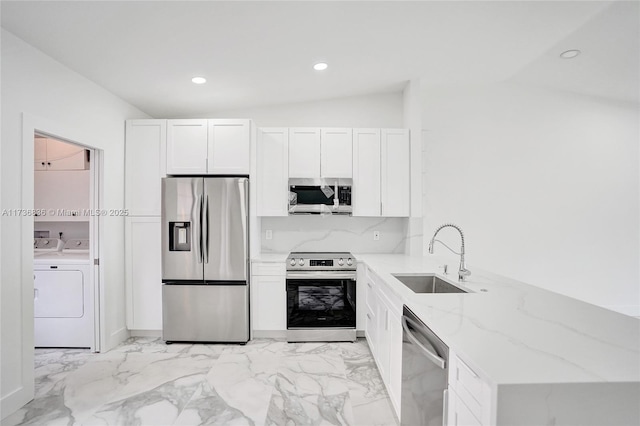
[{"xmin": 1, "ymin": 0, "xmax": 638, "ymax": 118}]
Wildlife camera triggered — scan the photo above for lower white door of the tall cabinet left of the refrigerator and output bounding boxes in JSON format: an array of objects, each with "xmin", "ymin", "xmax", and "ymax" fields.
[{"xmin": 125, "ymin": 217, "xmax": 162, "ymax": 330}]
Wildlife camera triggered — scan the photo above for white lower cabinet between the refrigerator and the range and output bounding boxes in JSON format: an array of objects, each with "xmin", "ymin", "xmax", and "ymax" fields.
[{"xmin": 251, "ymin": 262, "xmax": 287, "ymax": 332}]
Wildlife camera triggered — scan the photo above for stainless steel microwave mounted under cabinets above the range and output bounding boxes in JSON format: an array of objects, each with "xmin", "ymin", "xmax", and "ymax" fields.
[{"xmin": 289, "ymin": 179, "xmax": 353, "ymax": 215}]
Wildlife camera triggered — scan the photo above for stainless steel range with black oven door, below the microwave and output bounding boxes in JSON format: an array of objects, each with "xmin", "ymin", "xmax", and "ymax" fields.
[{"xmin": 287, "ymin": 253, "xmax": 356, "ymax": 342}]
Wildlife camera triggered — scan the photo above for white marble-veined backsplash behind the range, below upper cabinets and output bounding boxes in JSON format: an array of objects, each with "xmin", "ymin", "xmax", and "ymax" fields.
[{"xmin": 261, "ymin": 215, "xmax": 407, "ymax": 253}]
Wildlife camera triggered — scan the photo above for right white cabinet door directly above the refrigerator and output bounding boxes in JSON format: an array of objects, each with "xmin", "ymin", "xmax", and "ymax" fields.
[{"xmin": 207, "ymin": 120, "xmax": 251, "ymax": 175}]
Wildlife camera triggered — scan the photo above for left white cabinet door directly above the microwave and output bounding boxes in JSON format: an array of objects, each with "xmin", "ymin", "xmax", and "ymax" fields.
[{"xmin": 289, "ymin": 128, "xmax": 320, "ymax": 178}]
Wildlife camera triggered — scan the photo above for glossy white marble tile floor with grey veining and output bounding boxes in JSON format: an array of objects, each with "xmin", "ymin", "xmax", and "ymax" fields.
[{"xmin": 2, "ymin": 338, "xmax": 397, "ymax": 426}]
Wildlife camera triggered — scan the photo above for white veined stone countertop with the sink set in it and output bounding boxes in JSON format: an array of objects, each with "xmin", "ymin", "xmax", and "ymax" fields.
[{"xmin": 354, "ymin": 253, "xmax": 640, "ymax": 385}]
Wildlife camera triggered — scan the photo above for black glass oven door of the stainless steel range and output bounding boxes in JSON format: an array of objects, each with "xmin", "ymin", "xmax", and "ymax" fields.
[{"xmin": 287, "ymin": 273, "xmax": 356, "ymax": 330}]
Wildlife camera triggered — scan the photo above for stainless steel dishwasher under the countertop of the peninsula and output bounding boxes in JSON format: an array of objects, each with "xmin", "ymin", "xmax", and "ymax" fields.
[{"xmin": 400, "ymin": 306, "xmax": 449, "ymax": 426}]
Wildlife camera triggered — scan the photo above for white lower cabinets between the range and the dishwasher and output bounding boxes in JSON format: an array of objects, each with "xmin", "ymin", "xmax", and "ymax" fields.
[{"xmin": 365, "ymin": 269, "xmax": 402, "ymax": 417}]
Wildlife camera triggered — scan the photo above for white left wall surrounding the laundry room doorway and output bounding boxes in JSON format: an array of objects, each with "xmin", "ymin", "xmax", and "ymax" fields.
[{"xmin": 0, "ymin": 30, "xmax": 146, "ymax": 417}]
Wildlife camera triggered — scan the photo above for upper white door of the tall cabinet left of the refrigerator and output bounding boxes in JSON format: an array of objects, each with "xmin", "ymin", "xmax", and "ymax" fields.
[{"xmin": 124, "ymin": 120, "xmax": 167, "ymax": 216}]
